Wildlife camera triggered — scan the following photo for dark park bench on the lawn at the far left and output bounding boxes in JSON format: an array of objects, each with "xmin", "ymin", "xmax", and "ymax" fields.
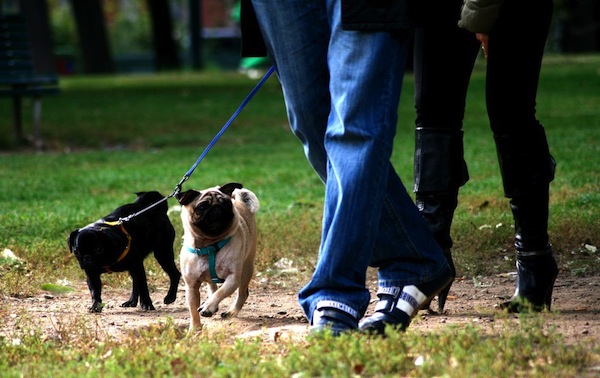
[{"xmin": 0, "ymin": 14, "xmax": 59, "ymax": 147}]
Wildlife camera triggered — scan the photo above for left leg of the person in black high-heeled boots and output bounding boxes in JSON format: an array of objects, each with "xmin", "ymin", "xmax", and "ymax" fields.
[{"xmin": 413, "ymin": 0, "xmax": 480, "ymax": 313}]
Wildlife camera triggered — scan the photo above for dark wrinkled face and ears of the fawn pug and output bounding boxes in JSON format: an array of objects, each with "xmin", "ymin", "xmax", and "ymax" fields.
[{"xmin": 177, "ymin": 184, "xmax": 241, "ymax": 238}]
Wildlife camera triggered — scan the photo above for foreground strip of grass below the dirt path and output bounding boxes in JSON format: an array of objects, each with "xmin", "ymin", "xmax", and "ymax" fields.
[{"xmin": 0, "ymin": 316, "xmax": 598, "ymax": 377}]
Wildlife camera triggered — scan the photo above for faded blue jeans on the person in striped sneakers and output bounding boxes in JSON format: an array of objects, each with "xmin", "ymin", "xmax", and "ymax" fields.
[{"xmin": 252, "ymin": 0, "xmax": 447, "ymax": 321}]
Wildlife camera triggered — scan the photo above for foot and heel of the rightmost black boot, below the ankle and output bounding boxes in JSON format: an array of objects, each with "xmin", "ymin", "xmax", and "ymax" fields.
[{"xmin": 500, "ymin": 247, "xmax": 558, "ymax": 312}]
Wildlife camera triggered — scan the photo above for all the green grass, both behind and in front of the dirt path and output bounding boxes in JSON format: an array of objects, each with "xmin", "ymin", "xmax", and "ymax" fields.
[{"xmin": 0, "ymin": 56, "xmax": 600, "ymax": 377}]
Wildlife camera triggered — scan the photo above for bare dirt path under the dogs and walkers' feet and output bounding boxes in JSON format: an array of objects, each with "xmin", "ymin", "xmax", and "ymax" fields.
[{"xmin": 0, "ymin": 275, "xmax": 600, "ymax": 345}]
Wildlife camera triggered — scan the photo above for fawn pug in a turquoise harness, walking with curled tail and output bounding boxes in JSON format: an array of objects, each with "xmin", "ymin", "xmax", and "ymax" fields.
[{"xmin": 177, "ymin": 183, "xmax": 259, "ymax": 332}]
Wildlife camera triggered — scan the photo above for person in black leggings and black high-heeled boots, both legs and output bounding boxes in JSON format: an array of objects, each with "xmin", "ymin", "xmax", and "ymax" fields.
[{"xmin": 414, "ymin": 0, "xmax": 558, "ymax": 312}]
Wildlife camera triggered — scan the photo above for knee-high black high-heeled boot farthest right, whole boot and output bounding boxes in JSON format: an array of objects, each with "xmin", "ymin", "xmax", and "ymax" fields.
[{"xmin": 494, "ymin": 125, "xmax": 558, "ymax": 312}]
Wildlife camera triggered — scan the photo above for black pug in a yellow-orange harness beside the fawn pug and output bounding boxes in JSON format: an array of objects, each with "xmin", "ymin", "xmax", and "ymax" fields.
[{"xmin": 67, "ymin": 191, "xmax": 181, "ymax": 312}]
